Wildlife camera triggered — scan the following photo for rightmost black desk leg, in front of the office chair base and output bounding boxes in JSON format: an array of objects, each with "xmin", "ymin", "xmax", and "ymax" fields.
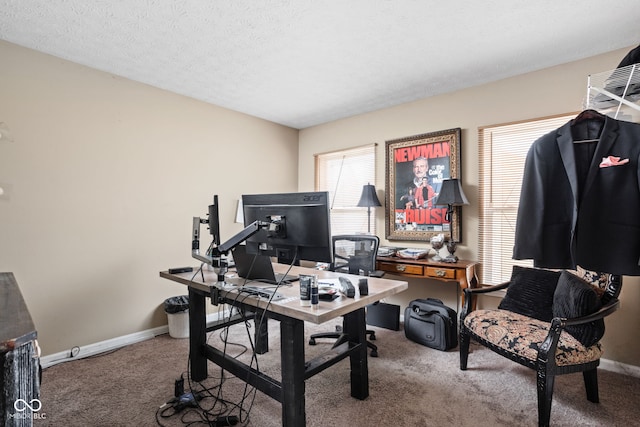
[{"xmin": 344, "ymin": 308, "xmax": 369, "ymax": 400}]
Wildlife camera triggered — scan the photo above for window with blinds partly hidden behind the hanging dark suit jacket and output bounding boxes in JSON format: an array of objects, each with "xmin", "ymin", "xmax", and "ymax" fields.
[{"xmin": 478, "ymin": 115, "xmax": 575, "ymax": 285}]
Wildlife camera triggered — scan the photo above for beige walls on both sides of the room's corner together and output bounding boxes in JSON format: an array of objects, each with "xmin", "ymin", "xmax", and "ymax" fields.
[{"xmin": 0, "ymin": 38, "xmax": 640, "ymax": 366}]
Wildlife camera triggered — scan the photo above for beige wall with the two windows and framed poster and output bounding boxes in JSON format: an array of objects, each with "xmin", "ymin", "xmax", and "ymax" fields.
[{"xmin": 298, "ymin": 47, "xmax": 640, "ymax": 366}]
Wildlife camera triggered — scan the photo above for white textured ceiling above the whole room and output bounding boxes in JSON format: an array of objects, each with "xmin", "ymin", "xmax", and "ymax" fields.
[{"xmin": 0, "ymin": 0, "xmax": 640, "ymax": 129}]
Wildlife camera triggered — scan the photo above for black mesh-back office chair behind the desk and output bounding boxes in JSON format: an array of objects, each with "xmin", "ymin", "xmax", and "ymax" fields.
[{"xmin": 309, "ymin": 234, "xmax": 384, "ymax": 357}]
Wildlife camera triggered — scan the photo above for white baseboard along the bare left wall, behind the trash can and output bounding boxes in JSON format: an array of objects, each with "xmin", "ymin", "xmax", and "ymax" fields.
[{"xmin": 40, "ymin": 312, "xmax": 228, "ymax": 369}]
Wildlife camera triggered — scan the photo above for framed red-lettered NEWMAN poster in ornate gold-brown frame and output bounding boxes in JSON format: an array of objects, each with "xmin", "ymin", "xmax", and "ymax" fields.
[{"xmin": 385, "ymin": 128, "xmax": 461, "ymax": 242}]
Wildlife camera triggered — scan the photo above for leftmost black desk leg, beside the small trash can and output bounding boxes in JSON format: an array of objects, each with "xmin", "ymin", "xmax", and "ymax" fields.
[{"xmin": 189, "ymin": 287, "xmax": 207, "ymax": 381}]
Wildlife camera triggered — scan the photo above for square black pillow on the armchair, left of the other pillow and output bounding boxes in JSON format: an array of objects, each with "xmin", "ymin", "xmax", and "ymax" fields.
[{"xmin": 498, "ymin": 265, "xmax": 560, "ymax": 322}]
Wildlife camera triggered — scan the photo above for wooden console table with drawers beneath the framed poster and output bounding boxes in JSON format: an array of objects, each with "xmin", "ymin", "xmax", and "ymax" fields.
[{"xmin": 376, "ymin": 256, "xmax": 478, "ymax": 309}]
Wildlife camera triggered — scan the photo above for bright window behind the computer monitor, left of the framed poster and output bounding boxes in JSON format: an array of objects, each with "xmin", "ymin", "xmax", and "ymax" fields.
[{"xmin": 315, "ymin": 144, "xmax": 379, "ymax": 235}]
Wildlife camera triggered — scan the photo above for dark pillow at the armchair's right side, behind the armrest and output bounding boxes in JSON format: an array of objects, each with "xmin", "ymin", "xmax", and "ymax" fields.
[{"xmin": 553, "ymin": 271, "xmax": 604, "ymax": 347}]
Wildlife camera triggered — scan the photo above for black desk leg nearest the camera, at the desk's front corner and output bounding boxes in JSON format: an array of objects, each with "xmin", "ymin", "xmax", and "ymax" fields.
[{"xmin": 280, "ymin": 318, "xmax": 306, "ymax": 427}]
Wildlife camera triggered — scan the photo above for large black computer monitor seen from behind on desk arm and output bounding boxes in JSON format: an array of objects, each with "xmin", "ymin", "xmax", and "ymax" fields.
[{"xmin": 242, "ymin": 191, "xmax": 332, "ymax": 264}]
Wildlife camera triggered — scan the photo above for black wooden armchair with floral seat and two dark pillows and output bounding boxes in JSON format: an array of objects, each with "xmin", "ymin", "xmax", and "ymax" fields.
[{"xmin": 460, "ymin": 267, "xmax": 622, "ymax": 426}]
